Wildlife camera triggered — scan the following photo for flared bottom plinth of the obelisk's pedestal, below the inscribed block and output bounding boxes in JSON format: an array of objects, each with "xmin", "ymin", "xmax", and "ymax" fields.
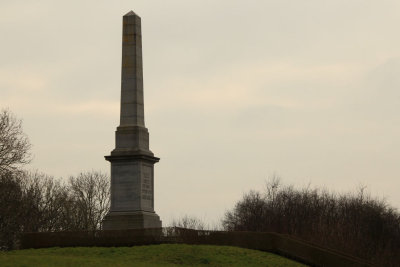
[{"xmin": 102, "ymin": 211, "xmax": 162, "ymax": 230}]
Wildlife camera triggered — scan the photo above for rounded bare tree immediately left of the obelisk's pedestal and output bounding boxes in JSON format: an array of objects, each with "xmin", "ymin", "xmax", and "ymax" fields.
[{"xmin": 69, "ymin": 171, "xmax": 110, "ymax": 230}]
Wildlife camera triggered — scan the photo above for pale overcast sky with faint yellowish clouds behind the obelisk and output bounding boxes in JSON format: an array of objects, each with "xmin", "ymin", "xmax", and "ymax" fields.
[{"xmin": 0, "ymin": 0, "xmax": 400, "ymax": 226}]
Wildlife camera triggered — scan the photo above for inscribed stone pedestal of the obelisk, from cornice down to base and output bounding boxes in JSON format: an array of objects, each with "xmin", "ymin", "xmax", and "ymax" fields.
[{"xmin": 103, "ymin": 151, "xmax": 161, "ymax": 230}]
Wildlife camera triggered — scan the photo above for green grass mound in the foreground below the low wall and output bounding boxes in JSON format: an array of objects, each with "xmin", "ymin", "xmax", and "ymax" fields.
[{"xmin": 0, "ymin": 244, "xmax": 305, "ymax": 267}]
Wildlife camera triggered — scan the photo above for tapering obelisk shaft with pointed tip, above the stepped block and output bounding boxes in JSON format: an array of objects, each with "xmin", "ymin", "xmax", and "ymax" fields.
[{"xmin": 120, "ymin": 11, "xmax": 145, "ymax": 127}]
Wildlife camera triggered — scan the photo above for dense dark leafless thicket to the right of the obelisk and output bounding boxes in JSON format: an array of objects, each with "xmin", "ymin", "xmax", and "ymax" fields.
[{"xmin": 222, "ymin": 179, "xmax": 400, "ymax": 266}]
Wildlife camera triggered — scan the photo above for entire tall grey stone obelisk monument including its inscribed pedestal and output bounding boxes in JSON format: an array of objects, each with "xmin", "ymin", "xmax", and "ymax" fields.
[{"xmin": 102, "ymin": 11, "xmax": 161, "ymax": 230}]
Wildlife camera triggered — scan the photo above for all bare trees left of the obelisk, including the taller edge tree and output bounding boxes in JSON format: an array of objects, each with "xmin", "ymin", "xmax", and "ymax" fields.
[{"xmin": 0, "ymin": 110, "xmax": 110, "ymax": 249}]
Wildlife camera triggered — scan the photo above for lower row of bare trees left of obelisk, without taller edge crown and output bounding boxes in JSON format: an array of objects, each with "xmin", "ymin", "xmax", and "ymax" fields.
[{"xmin": 0, "ymin": 171, "xmax": 110, "ymax": 249}]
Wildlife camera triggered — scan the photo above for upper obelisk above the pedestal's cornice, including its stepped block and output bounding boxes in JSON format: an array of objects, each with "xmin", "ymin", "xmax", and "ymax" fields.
[{"xmin": 111, "ymin": 11, "xmax": 153, "ymax": 156}]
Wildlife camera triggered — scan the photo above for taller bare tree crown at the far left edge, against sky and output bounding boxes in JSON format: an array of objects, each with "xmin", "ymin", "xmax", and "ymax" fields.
[{"xmin": 0, "ymin": 109, "xmax": 31, "ymax": 176}]
